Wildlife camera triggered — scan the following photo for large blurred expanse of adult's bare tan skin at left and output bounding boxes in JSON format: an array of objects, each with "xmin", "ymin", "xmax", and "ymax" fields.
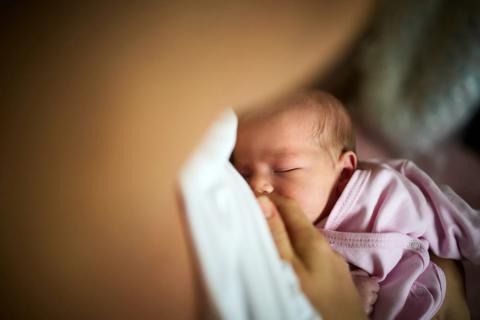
[{"xmin": 0, "ymin": 0, "xmax": 464, "ymax": 319}]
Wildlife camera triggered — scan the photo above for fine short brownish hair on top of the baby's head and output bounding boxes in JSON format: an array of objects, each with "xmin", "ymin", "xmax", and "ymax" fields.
[{"xmin": 241, "ymin": 90, "xmax": 355, "ymax": 156}]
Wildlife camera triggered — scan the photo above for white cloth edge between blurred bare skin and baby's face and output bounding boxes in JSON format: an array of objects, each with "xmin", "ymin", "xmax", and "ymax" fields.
[{"xmin": 180, "ymin": 110, "xmax": 320, "ymax": 319}]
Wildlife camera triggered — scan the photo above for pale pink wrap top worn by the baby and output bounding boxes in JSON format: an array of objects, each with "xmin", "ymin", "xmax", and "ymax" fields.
[{"xmin": 318, "ymin": 160, "xmax": 480, "ymax": 319}]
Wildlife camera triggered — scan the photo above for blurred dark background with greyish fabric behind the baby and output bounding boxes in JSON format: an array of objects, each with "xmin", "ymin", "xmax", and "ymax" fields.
[{"xmin": 312, "ymin": 0, "xmax": 480, "ymax": 319}]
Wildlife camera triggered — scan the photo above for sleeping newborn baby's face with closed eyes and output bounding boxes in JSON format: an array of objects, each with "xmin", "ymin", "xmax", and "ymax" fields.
[{"xmin": 233, "ymin": 110, "xmax": 339, "ymax": 222}]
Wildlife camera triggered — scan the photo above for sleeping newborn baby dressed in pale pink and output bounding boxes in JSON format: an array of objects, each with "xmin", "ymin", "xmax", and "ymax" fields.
[{"xmin": 232, "ymin": 91, "xmax": 480, "ymax": 319}]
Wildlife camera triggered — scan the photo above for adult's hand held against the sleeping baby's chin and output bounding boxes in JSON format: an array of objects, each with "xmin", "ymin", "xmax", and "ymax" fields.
[{"xmin": 258, "ymin": 194, "xmax": 367, "ymax": 319}]
